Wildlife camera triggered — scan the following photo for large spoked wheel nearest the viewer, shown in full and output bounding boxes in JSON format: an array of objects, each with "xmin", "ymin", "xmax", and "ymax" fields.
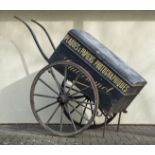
[{"xmin": 30, "ymin": 61, "xmax": 99, "ymax": 136}]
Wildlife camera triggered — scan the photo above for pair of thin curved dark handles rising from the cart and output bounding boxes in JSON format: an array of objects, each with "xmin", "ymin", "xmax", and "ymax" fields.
[{"xmin": 14, "ymin": 16, "xmax": 55, "ymax": 63}]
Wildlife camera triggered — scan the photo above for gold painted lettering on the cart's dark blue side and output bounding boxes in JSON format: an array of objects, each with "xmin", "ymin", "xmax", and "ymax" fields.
[{"xmin": 64, "ymin": 34, "xmax": 130, "ymax": 93}]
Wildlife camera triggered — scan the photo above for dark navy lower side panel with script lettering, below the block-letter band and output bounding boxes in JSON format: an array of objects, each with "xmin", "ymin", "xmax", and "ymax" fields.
[{"xmin": 50, "ymin": 41, "xmax": 123, "ymax": 111}]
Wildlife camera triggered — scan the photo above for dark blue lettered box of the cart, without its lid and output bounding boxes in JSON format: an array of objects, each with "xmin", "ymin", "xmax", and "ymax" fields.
[{"xmin": 50, "ymin": 30, "xmax": 146, "ymax": 113}]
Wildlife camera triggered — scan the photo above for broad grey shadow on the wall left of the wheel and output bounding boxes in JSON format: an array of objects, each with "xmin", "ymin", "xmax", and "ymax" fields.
[{"xmin": 0, "ymin": 74, "xmax": 36, "ymax": 124}]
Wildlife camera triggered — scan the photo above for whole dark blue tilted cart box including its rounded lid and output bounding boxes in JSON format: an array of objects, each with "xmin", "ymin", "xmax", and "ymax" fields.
[{"xmin": 49, "ymin": 30, "xmax": 146, "ymax": 113}]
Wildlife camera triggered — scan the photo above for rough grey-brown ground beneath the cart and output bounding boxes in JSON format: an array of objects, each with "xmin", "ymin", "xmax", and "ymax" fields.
[{"xmin": 0, "ymin": 124, "xmax": 155, "ymax": 145}]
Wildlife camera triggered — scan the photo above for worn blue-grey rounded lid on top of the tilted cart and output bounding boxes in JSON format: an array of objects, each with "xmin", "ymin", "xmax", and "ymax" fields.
[{"xmin": 69, "ymin": 29, "xmax": 146, "ymax": 86}]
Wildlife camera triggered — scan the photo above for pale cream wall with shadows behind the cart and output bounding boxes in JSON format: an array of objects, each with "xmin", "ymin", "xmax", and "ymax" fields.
[{"xmin": 0, "ymin": 11, "xmax": 155, "ymax": 124}]
